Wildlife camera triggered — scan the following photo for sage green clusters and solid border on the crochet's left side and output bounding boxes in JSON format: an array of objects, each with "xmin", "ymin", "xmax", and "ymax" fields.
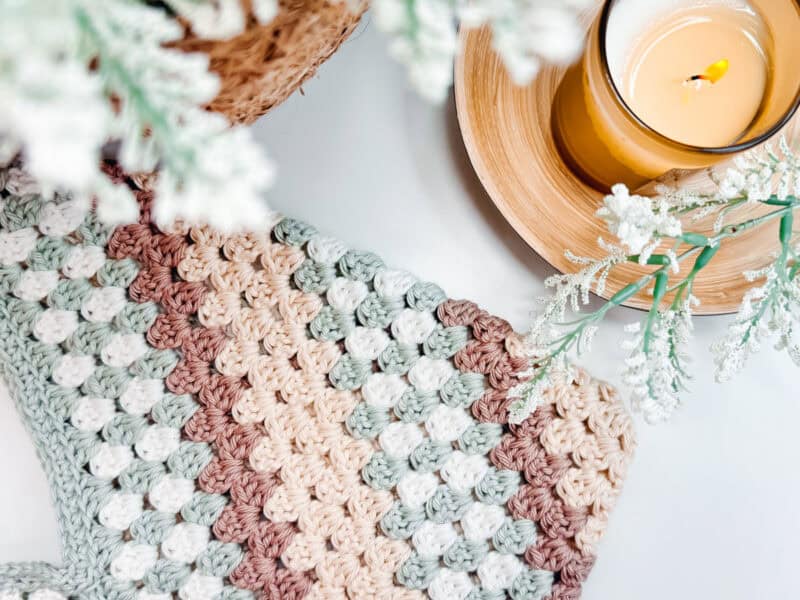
[{"xmin": 0, "ymin": 185, "xmax": 247, "ymax": 600}]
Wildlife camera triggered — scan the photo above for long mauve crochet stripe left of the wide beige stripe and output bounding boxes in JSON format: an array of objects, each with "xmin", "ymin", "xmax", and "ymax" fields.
[{"xmin": 108, "ymin": 169, "xmax": 311, "ymax": 600}]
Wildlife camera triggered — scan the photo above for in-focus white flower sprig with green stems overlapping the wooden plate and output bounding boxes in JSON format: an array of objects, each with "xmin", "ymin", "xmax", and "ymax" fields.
[{"xmin": 509, "ymin": 140, "xmax": 800, "ymax": 423}]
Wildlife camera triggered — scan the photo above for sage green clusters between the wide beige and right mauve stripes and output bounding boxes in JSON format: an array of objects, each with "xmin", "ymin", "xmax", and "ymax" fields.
[{"xmin": 274, "ymin": 219, "xmax": 552, "ymax": 600}]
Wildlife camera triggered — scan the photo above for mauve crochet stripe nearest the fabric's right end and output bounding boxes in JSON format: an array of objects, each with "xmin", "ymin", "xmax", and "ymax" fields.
[{"xmin": 438, "ymin": 300, "xmax": 633, "ymax": 600}]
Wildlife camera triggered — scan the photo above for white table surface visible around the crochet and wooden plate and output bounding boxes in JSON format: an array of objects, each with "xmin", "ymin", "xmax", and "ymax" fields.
[{"xmin": 0, "ymin": 16, "xmax": 800, "ymax": 600}]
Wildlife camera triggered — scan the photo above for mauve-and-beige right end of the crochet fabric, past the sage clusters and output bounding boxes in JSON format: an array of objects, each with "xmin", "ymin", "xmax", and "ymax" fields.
[{"xmin": 438, "ymin": 300, "xmax": 635, "ymax": 600}]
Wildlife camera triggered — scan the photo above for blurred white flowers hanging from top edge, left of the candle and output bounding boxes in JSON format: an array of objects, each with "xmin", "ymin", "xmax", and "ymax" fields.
[{"xmin": 371, "ymin": 0, "xmax": 596, "ymax": 102}]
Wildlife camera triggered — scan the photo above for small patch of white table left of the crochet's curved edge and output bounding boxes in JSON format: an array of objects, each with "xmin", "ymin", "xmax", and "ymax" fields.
[{"xmin": 0, "ymin": 379, "xmax": 61, "ymax": 564}]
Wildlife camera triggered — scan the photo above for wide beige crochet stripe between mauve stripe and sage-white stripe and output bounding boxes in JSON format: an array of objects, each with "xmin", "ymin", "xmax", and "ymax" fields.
[{"xmin": 178, "ymin": 230, "xmax": 423, "ymax": 600}]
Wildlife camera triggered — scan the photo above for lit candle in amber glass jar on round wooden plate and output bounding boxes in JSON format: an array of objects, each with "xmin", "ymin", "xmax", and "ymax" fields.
[{"xmin": 553, "ymin": 0, "xmax": 800, "ymax": 189}]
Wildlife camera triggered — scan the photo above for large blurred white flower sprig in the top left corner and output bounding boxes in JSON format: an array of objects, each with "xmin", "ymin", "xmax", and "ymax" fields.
[{"xmin": 0, "ymin": 0, "xmax": 276, "ymax": 229}]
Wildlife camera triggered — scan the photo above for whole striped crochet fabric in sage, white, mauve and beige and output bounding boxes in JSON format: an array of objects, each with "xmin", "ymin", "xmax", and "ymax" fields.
[{"xmin": 0, "ymin": 165, "xmax": 634, "ymax": 600}]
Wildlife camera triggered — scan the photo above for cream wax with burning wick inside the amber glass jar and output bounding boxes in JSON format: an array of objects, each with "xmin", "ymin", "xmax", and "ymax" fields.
[{"xmin": 611, "ymin": 6, "xmax": 772, "ymax": 146}]
